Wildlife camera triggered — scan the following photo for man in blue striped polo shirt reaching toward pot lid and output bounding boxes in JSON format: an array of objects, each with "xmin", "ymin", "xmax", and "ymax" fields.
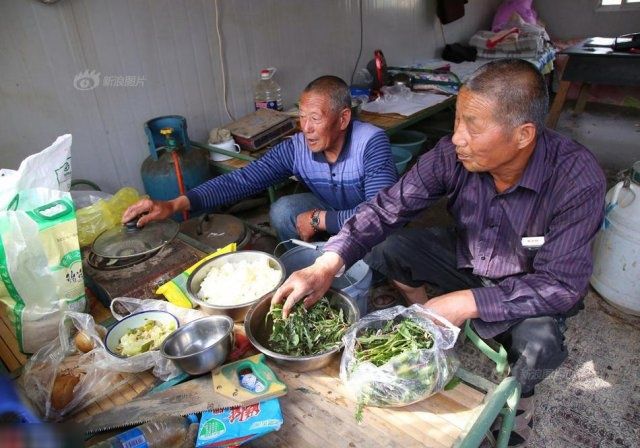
[{"xmin": 122, "ymin": 76, "xmax": 398, "ymax": 245}]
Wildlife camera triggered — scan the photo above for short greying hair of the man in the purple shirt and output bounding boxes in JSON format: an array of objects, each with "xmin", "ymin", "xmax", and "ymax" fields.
[{"xmin": 463, "ymin": 58, "xmax": 549, "ymax": 130}]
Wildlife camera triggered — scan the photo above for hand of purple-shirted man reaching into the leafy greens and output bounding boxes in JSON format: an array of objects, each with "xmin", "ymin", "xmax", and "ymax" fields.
[{"xmin": 271, "ymin": 252, "xmax": 344, "ymax": 318}]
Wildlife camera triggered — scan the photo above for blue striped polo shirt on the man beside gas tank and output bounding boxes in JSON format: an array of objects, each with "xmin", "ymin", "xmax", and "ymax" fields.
[{"xmin": 182, "ymin": 121, "xmax": 398, "ymax": 234}]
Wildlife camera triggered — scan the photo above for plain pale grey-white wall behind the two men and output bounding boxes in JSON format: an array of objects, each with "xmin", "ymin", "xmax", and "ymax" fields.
[{"xmin": 0, "ymin": 0, "xmax": 498, "ymax": 192}]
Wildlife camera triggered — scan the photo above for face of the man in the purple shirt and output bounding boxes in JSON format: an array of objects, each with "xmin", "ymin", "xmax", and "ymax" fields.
[{"xmin": 452, "ymin": 87, "xmax": 518, "ymax": 172}]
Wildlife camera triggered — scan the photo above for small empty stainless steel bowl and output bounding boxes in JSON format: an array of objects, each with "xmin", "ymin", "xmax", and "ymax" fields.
[{"xmin": 160, "ymin": 316, "xmax": 233, "ymax": 375}]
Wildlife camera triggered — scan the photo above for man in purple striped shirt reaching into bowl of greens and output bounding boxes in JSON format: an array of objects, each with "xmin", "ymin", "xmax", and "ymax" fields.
[{"xmin": 273, "ymin": 59, "xmax": 605, "ymax": 446}]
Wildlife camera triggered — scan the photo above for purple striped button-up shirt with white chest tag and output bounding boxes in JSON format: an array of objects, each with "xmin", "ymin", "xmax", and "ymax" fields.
[{"xmin": 325, "ymin": 129, "xmax": 605, "ymax": 338}]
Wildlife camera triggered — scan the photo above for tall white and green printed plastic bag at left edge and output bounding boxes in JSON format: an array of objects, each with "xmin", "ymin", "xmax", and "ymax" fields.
[{"xmin": 0, "ymin": 135, "xmax": 86, "ymax": 353}]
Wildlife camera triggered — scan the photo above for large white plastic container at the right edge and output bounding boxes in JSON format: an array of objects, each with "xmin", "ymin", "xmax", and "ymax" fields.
[{"xmin": 591, "ymin": 162, "xmax": 640, "ymax": 315}]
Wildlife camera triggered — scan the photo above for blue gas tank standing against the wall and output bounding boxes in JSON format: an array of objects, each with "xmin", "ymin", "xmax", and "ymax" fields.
[{"xmin": 140, "ymin": 115, "xmax": 211, "ymax": 219}]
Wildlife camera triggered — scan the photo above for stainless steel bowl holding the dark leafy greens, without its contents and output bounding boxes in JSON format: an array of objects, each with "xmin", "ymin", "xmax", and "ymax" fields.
[{"xmin": 244, "ymin": 289, "xmax": 360, "ymax": 372}]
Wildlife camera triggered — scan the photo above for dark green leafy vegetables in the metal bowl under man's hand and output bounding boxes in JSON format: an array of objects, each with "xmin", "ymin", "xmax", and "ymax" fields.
[{"xmin": 266, "ymin": 297, "xmax": 349, "ymax": 356}]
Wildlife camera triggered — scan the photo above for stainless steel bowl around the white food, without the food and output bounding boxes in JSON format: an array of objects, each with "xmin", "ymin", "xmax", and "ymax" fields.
[{"xmin": 187, "ymin": 250, "xmax": 285, "ymax": 322}]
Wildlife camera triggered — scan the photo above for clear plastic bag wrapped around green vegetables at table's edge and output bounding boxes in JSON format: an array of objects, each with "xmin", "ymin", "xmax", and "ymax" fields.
[{"xmin": 340, "ymin": 305, "xmax": 460, "ymax": 421}]
